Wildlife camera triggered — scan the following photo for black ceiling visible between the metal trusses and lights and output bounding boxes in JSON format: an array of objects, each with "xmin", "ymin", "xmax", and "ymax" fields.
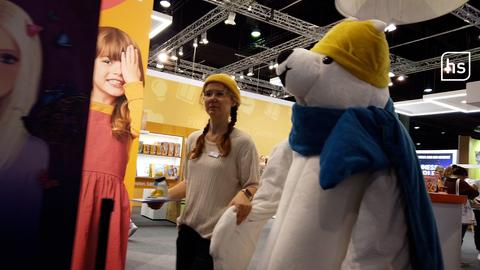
[{"xmin": 150, "ymin": 0, "xmax": 480, "ymax": 149}]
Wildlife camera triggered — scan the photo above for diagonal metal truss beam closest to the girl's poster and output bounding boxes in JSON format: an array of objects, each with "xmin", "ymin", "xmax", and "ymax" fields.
[{"xmin": 148, "ymin": 7, "xmax": 228, "ymax": 64}]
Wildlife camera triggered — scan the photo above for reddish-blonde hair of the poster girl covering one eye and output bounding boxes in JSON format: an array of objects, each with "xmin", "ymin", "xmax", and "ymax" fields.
[{"xmin": 96, "ymin": 27, "xmax": 145, "ymax": 139}]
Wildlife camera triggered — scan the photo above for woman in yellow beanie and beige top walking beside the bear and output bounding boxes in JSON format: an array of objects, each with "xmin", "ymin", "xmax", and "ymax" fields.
[{"xmin": 150, "ymin": 74, "xmax": 259, "ymax": 270}]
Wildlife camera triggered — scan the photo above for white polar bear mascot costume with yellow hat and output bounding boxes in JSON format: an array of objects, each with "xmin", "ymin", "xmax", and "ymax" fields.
[{"xmin": 210, "ymin": 20, "xmax": 443, "ymax": 270}]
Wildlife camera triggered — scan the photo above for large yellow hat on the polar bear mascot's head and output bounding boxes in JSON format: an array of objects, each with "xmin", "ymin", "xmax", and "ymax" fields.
[{"xmin": 311, "ymin": 20, "xmax": 390, "ymax": 88}]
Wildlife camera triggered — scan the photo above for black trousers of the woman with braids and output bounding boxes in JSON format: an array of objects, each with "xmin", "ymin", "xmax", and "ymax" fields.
[{"xmin": 177, "ymin": 225, "xmax": 213, "ymax": 270}]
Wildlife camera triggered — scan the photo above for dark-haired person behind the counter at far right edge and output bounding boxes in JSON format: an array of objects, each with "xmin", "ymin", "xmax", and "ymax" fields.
[{"xmin": 445, "ymin": 165, "xmax": 479, "ymax": 247}]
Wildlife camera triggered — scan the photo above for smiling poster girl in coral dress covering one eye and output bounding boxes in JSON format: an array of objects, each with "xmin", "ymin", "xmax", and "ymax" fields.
[{"xmin": 71, "ymin": 27, "xmax": 144, "ymax": 270}]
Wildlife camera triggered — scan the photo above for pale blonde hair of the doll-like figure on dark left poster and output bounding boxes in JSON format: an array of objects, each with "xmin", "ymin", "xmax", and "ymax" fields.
[{"xmin": 0, "ymin": 0, "xmax": 42, "ymax": 169}]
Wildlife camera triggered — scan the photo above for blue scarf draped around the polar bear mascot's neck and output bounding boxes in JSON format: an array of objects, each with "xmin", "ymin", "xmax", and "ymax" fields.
[{"xmin": 289, "ymin": 100, "xmax": 443, "ymax": 270}]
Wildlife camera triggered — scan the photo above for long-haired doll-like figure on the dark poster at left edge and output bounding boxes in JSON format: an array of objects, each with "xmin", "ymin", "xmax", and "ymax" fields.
[{"xmin": 0, "ymin": 0, "xmax": 50, "ymax": 269}]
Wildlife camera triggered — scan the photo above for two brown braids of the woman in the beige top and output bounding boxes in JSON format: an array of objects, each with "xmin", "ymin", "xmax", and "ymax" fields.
[{"xmin": 189, "ymin": 85, "xmax": 240, "ymax": 159}]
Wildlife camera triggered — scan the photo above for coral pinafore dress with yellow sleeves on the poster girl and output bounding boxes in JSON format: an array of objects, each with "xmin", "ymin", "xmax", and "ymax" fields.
[{"xmin": 71, "ymin": 83, "xmax": 143, "ymax": 270}]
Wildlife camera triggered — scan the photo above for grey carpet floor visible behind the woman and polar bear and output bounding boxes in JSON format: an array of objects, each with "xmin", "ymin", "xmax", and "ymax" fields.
[{"xmin": 126, "ymin": 207, "xmax": 480, "ymax": 270}]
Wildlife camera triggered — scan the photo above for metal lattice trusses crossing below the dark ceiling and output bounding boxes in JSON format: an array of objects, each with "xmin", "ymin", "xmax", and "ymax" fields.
[{"xmin": 149, "ymin": 0, "xmax": 480, "ymax": 96}]
